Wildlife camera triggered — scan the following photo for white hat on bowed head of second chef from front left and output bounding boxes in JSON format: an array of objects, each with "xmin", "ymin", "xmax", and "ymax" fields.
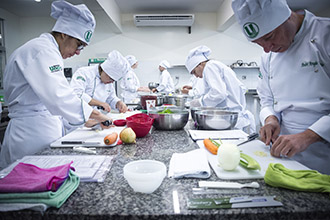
[{"xmin": 101, "ymin": 50, "xmax": 131, "ymax": 81}]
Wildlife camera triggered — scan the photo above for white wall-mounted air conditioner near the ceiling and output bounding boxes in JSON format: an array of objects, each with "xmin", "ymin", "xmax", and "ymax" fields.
[{"xmin": 134, "ymin": 14, "xmax": 194, "ymax": 27}]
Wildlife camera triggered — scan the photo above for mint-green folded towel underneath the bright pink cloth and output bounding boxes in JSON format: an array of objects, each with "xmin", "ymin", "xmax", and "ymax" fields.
[{"xmin": 0, "ymin": 170, "xmax": 80, "ymax": 208}]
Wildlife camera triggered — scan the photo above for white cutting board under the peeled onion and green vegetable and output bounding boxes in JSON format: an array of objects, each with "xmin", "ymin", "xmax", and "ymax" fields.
[{"xmin": 196, "ymin": 140, "xmax": 309, "ymax": 180}]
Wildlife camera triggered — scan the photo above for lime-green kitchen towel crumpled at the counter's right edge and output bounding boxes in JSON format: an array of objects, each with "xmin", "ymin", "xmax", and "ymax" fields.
[{"xmin": 264, "ymin": 163, "xmax": 330, "ymax": 193}]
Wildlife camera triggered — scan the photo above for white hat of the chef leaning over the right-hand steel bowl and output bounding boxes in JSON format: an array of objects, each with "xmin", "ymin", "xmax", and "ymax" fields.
[{"xmin": 185, "ymin": 45, "xmax": 212, "ymax": 73}]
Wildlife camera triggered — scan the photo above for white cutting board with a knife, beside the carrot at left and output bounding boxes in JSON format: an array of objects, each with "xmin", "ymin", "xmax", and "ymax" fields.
[{"xmin": 50, "ymin": 126, "xmax": 125, "ymax": 147}]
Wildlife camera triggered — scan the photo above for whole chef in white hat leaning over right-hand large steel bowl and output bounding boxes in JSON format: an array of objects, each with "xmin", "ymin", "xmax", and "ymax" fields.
[{"xmin": 185, "ymin": 45, "xmax": 256, "ymax": 133}]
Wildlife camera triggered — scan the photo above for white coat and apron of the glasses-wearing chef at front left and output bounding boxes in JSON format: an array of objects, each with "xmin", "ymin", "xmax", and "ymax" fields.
[{"xmin": 0, "ymin": 33, "xmax": 93, "ymax": 168}]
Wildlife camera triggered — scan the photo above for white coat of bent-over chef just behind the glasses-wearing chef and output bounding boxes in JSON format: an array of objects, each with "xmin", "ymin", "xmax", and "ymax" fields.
[{"xmin": 70, "ymin": 65, "xmax": 120, "ymax": 109}]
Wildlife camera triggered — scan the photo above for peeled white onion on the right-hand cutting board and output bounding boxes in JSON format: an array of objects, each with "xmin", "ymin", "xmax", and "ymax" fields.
[{"xmin": 217, "ymin": 143, "xmax": 240, "ymax": 170}]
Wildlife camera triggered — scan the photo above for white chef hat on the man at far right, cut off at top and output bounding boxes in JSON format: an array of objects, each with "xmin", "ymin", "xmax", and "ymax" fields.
[{"xmin": 232, "ymin": 0, "xmax": 291, "ymax": 41}]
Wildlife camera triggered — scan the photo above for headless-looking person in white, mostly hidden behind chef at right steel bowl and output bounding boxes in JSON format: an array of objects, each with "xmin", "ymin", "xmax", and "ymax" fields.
[{"xmin": 181, "ymin": 75, "xmax": 205, "ymax": 98}]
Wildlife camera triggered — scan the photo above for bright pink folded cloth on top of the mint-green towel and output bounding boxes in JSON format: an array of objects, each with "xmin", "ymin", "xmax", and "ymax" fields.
[{"xmin": 0, "ymin": 161, "xmax": 74, "ymax": 193}]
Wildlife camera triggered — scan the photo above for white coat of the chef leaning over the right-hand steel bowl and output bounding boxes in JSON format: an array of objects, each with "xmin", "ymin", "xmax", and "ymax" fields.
[{"xmin": 200, "ymin": 60, "xmax": 256, "ymax": 133}]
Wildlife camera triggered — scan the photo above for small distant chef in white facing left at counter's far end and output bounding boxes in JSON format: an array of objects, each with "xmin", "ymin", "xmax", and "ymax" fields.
[{"xmin": 152, "ymin": 60, "xmax": 174, "ymax": 94}]
